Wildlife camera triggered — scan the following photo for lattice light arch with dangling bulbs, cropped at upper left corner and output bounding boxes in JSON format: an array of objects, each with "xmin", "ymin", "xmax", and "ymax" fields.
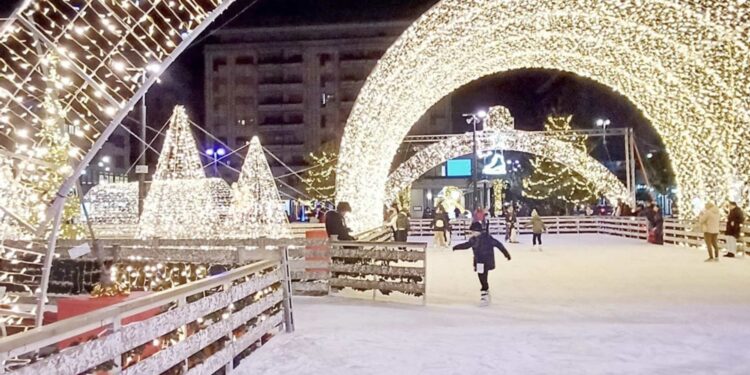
[{"xmin": 0, "ymin": 0, "xmax": 239, "ymax": 235}]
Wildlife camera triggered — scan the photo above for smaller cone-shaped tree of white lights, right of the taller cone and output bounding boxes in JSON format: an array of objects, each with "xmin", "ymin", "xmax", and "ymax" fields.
[{"xmin": 227, "ymin": 137, "xmax": 290, "ymax": 238}]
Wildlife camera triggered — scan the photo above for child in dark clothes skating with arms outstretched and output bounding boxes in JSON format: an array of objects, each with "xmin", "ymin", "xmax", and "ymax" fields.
[{"xmin": 453, "ymin": 222, "xmax": 510, "ymax": 306}]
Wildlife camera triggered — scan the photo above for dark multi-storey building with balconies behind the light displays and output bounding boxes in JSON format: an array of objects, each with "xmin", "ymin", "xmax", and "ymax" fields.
[{"xmin": 204, "ymin": 22, "xmax": 452, "ymax": 185}]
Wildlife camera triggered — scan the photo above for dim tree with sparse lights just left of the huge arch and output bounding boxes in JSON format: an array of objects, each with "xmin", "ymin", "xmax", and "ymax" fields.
[{"xmin": 304, "ymin": 143, "xmax": 338, "ymax": 202}]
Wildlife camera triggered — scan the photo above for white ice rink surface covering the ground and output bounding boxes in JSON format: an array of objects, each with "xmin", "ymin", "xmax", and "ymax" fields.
[{"xmin": 237, "ymin": 235, "xmax": 750, "ymax": 375}]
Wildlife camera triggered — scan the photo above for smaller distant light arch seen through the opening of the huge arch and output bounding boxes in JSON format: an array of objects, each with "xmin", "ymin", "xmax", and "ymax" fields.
[{"xmin": 384, "ymin": 130, "xmax": 632, "ymax": 205}]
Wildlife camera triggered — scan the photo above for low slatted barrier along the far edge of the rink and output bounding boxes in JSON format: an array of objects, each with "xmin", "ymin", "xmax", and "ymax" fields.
[{"xmin": 409, "ymin": 216, "xmax": 750, "ymax": 254}]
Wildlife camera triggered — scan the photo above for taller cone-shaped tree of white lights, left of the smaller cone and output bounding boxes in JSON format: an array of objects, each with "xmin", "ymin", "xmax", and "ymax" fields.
[{"xmin": 137, "ymin": 106, "xmax": 232, "ymax": 239}]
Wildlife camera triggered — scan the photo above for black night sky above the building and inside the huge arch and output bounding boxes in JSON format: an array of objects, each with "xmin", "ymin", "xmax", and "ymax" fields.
[{"xmin": 0, "ymin": 0, "xmax": 663, "ymax": 159}]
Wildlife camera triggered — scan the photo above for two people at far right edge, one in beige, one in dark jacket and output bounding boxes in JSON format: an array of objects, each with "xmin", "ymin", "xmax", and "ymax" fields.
[{"xmin": 698, "ymin": 202, "xmax": 745, "ymax": 262}]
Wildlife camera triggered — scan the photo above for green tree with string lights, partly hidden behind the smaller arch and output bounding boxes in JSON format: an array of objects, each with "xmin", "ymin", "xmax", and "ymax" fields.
[{"xmin": 523, "ymin": 116, "xmax": 597, "ymax": 204}]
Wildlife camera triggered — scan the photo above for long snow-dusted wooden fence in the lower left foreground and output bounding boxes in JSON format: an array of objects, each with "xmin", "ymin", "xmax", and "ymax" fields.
[{"xmin": 0, "ymin": 261, "xmax": 293, "ymax": 375}]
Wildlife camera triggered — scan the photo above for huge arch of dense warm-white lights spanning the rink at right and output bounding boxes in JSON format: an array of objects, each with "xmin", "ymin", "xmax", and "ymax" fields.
[{"xmin": 337, "ymin": 0, "xmax": 750, "ymax": 229}]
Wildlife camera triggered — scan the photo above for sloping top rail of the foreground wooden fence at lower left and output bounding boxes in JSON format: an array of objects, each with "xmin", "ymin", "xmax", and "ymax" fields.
[{"xmin": 0, "ymin": 260, "xmax": 278, "ymax": 358}]
